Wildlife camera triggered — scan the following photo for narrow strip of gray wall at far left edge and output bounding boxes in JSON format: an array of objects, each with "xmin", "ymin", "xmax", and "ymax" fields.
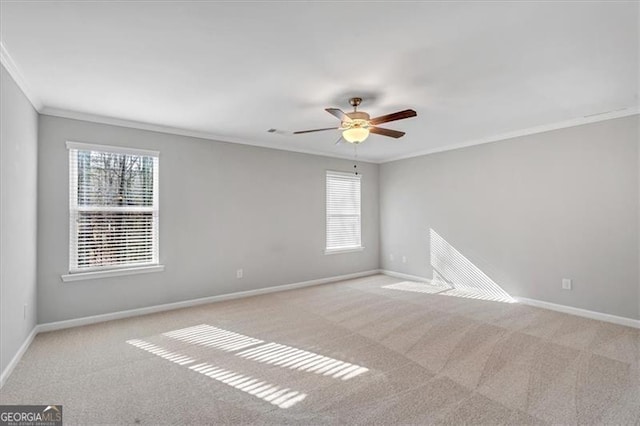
[{"xmin": 0, "ymin": 66, "xmax": 38, "ymax": 371}]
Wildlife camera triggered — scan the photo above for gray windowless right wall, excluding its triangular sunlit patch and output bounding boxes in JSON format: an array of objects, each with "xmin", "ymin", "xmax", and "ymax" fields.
[{"xmin": 380, "ymin": 115, "xmax": 640, "ymax": 318}]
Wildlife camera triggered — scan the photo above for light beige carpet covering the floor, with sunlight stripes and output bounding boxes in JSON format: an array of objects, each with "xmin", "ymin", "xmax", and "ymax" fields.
[{"xmin": 0, "ymin": 275, "xmax": 640, "ymax": 425}]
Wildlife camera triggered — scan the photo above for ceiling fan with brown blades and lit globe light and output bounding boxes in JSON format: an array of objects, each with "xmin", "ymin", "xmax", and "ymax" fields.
[{"xmin": 293, "ymin": 98, "xmax": 418, "ymax": 144}]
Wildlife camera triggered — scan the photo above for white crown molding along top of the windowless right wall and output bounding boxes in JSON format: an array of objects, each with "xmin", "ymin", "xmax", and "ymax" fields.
[{"xmin": 379, "ymin": 106, "xmax": 640, "ymax": 164}]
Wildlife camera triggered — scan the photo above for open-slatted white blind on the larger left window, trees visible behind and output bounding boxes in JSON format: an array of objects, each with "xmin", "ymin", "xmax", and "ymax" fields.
[{"xmin": 67, "ymin": 142, "xmax": 158, "ymax": 273}]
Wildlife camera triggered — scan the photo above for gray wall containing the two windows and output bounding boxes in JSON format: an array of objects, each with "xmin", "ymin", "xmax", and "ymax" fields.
[{"xmin": 38, "ymin": 115, "xmax": 379, "ymax": 323}]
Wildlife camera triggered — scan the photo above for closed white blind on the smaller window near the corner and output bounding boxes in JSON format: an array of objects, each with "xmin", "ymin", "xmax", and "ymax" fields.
[{"xmin": 326, "ymin": 171, "xmax": 361, "ymax": 251}]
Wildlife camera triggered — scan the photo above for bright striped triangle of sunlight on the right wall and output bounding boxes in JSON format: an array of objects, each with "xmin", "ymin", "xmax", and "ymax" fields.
[{"xmin": 429, "ymin": 229, "xmax": 515, "ymax": 303}]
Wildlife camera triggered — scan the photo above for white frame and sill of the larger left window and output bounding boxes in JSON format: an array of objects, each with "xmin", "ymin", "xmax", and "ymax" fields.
[{"xmin": 62, "ymin": 141, "xmax": 164, "ymax": 281}]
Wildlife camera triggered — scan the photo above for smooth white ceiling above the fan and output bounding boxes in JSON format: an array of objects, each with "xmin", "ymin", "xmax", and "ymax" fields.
[{"xmin": 0, "ymin": 1, "xmax": 639, "ymax": 162}]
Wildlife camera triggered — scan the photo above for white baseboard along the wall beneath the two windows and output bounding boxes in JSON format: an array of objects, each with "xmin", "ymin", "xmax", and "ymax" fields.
[{"xmin": 43, "ymin": 269, "xmax": 380, "ymax": 333}]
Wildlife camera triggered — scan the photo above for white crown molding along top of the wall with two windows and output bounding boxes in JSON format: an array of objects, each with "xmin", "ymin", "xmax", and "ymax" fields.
[{"xmin": 39, "ymin": 106, "xmax": 378, "ymax": 164}]
